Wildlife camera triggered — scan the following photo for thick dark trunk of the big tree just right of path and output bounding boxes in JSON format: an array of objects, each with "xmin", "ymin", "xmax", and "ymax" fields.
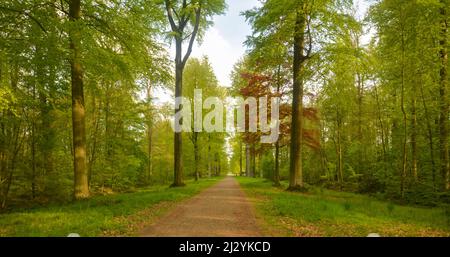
[{"xmin": 288, "ymin": 10, "xmax": 307, "ymax": 190}]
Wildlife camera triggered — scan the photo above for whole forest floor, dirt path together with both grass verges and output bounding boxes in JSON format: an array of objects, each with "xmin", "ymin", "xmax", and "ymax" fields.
[{"xmin": 0, "ymin": 177, "xmax": 450, "ymax": 237}]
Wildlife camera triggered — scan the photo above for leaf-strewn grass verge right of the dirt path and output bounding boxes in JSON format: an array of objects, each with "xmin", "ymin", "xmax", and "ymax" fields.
[{"xmin": 238, "ymin": 177, "xmax": 450, "ymax": 237}]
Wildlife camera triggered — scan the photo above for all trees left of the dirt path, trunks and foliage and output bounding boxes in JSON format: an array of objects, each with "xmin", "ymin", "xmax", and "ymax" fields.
[{"xmin": 0, "ymin": 0, "xmax": 227, "ymax": 208}]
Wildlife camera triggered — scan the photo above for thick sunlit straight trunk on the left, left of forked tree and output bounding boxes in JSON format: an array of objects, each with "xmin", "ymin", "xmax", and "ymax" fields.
[{"xmin": 69, "ymin": 0, "xmax": 89, "ymax": 199}]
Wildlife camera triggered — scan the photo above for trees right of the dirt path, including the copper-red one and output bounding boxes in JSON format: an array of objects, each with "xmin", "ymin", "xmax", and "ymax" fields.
[{"xmin": 232, "ymin": 0, "xmax": 450, "ymax": 205}]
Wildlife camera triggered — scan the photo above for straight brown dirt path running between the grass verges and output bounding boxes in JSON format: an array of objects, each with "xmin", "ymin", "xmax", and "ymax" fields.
[{"xmin": 141, "ymin": 177, "xmax": 260, "ymax": 237}]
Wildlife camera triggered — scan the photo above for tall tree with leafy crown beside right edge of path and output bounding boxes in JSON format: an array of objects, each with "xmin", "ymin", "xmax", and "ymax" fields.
[{"xmin": 245, "ymin": 0, "xmax": 349, "ymax": 190}]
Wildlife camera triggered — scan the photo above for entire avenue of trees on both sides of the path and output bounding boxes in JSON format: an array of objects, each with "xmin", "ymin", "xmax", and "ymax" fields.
[{"xmin": 0, "ymin": 0, "xmax": 450, "ymax": 209}]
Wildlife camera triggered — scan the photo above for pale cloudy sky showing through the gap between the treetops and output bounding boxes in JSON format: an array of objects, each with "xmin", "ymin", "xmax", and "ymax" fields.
[{"xmin": 156, "ymin": 0, "xmax": 369, "ymax": 102}]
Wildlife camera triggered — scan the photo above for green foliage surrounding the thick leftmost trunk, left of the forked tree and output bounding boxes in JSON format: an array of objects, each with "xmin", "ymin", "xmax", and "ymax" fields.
[{"xmin": 0, "ymin": 0, "xmax": 171, "ymax": 208}]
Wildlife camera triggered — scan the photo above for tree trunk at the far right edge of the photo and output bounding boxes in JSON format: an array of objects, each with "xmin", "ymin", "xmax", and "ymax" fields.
[{"xmin": 439, "ymin": 0, "xmax": 450, "ymax": 190}]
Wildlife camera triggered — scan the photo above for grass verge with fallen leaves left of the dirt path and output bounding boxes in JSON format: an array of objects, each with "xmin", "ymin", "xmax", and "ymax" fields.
[{"xmin": 0, "ymin": 178, "xmax": 219, "ymax": 237}]
